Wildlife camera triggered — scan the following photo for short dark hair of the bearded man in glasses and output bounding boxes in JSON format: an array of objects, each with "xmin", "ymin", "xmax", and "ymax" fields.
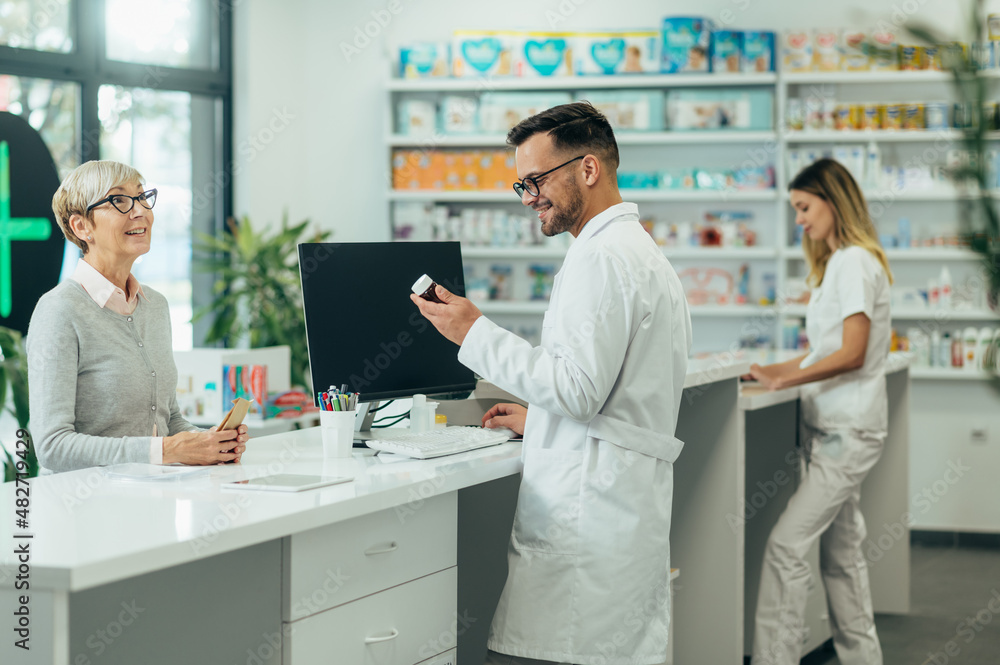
[{"xmin": 507, "ymin": 102, "xmax": 619, "ymax": 176}]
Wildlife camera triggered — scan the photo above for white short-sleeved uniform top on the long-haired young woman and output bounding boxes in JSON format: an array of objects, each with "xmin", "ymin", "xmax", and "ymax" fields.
[{"xmin": 800, "ymin": 246, "xmax": 892, "ymax": 432}]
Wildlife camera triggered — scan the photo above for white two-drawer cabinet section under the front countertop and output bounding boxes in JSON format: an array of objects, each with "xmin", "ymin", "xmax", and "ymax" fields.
[{"xmin": 282, "ymin": 492, "xmax": 458, "ymax": 665}]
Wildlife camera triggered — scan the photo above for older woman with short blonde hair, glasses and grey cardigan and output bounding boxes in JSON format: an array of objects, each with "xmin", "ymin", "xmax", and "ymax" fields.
[{"xmin": 26, "ymin": 161, "xmax": 248, "ymax": 471}]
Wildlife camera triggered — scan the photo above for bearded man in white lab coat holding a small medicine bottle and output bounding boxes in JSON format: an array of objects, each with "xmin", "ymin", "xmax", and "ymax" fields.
[{"xmin": 413, "ymin": 103, "xmax": 691, "ymax": 665}]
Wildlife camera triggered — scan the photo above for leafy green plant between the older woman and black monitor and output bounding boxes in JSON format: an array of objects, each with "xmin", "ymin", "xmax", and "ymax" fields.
[{"xmin": 188, "ymin": 213, "xmax": 330, "ymax": 392}]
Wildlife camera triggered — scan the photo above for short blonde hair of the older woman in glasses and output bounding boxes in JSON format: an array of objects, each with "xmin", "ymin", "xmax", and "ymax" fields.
[{"xmin": 52, "ymin": 160, "xmax": 145, "ymax": 254}]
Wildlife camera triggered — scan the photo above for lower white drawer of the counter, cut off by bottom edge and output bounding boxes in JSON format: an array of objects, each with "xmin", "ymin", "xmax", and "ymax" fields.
[{"xmin": 282, "ymin": 567, "xmax": 458, "ymax": 665}]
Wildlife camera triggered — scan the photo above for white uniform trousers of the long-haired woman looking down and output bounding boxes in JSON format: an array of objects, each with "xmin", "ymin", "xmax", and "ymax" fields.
[{"xmin": 753, "ymin": 427, "xmax": 885, "ymax": 665}]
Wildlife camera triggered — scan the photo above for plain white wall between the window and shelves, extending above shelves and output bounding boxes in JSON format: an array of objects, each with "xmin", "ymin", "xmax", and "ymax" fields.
[{"xmin": 234, "ymin": 0, "xmax": 984, "ymax": 240}]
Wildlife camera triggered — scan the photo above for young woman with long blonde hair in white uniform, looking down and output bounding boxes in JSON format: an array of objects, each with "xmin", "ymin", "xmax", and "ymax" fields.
[{"xmin": 750, "ymin": 159, "xmax": 892, "ymax": 665}]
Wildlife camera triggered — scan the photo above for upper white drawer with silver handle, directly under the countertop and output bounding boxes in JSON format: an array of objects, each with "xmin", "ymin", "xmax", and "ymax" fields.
[{"xmin": 281, "ymin": 492, "xmax": 458, "ymax": 621}]
